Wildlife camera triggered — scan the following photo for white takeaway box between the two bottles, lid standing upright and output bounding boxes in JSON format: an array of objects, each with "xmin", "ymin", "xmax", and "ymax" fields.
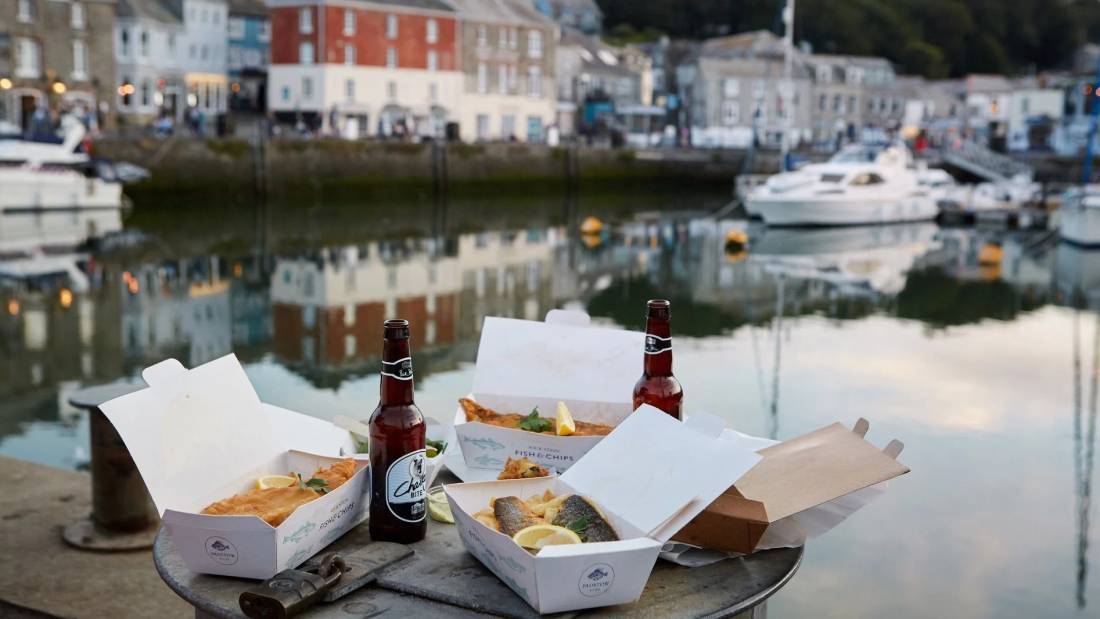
[{"xmin": 454, "ymin": 310, "xmax": 645, "ymax": 471}]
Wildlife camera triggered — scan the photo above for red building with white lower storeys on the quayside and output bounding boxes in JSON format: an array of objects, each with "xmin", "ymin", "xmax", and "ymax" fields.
[{"xmin": 267, "ymin": 0, "xmax": 462, "ymax": 137}]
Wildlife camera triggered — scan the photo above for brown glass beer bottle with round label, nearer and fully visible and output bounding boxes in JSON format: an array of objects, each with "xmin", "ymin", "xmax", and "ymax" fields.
[{"xmin": 370, "ymin": 320, "xmax": 428, "ymax": 544}]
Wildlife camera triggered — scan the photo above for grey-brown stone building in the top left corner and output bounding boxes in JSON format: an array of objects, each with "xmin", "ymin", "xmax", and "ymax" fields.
[{"xmin": 0, "ymin": 0, "xmax": 116, "ymax": 131}]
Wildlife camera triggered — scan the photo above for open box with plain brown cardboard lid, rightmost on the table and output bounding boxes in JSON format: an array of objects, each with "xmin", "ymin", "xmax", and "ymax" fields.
[{"xmin": 672, "ymin": 419, "xmax": 909, "ymax": 554}]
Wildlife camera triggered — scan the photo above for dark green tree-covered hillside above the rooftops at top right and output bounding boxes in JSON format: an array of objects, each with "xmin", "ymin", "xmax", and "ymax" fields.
[{"xmin": 597, "ymin": 0, "xmax": 1100, "ymax": 78}]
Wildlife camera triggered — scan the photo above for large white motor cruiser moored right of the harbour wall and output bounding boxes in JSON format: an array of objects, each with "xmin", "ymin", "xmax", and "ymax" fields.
[{"xmin": 746, "ymin": 143, "xmax": 939, "ymax": 225}]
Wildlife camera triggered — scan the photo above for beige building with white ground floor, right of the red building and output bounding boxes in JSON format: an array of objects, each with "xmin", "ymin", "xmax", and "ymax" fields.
[{"xmin": 450, "ymin": 0, "xmax": 557, "ymax": 142}]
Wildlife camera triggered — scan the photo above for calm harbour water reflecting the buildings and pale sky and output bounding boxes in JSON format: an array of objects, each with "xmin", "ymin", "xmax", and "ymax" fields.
[{"xmin": 0, "ymin": 200, "xmax": 1100, "ymax": 617}]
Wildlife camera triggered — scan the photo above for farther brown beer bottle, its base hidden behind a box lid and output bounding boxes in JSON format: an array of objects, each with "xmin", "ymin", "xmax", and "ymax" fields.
[{"xmin": 634, "ymin": 299, "xmax": 684, "ymax": 419}]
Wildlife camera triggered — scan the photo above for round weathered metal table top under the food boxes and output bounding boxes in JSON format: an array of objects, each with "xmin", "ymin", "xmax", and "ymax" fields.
[{"xmin": 153, "ymin": 477, "xmax": 802, "ymax": 619}]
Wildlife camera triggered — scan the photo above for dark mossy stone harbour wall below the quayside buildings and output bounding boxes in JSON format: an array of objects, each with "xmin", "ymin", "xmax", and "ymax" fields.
[{"xmin": 96, "ymin": 139, "xmax": 778, "ymax": 203}]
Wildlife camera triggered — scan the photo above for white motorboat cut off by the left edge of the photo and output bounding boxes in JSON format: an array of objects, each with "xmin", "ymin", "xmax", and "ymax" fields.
[{"xmin": 0, "ymin": 119, "xmax": 122, "ymax": 212}]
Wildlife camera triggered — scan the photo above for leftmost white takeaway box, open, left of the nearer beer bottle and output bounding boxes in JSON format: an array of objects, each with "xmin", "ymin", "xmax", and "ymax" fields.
[{"xmin": 100, "ymin": 355, "xmax": 371, "ymax": 578}]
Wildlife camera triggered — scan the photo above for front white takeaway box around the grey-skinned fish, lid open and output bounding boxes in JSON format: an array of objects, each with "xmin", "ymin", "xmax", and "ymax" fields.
[{"xmin": 443, "ymin": 405, "xmax": 760, "ymax": 612}]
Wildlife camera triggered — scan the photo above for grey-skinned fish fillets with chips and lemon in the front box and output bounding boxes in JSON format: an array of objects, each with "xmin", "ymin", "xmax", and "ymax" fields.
[{"xmin": 474, "ymin": 490, "xmax": 619, "ymax": 552}]
